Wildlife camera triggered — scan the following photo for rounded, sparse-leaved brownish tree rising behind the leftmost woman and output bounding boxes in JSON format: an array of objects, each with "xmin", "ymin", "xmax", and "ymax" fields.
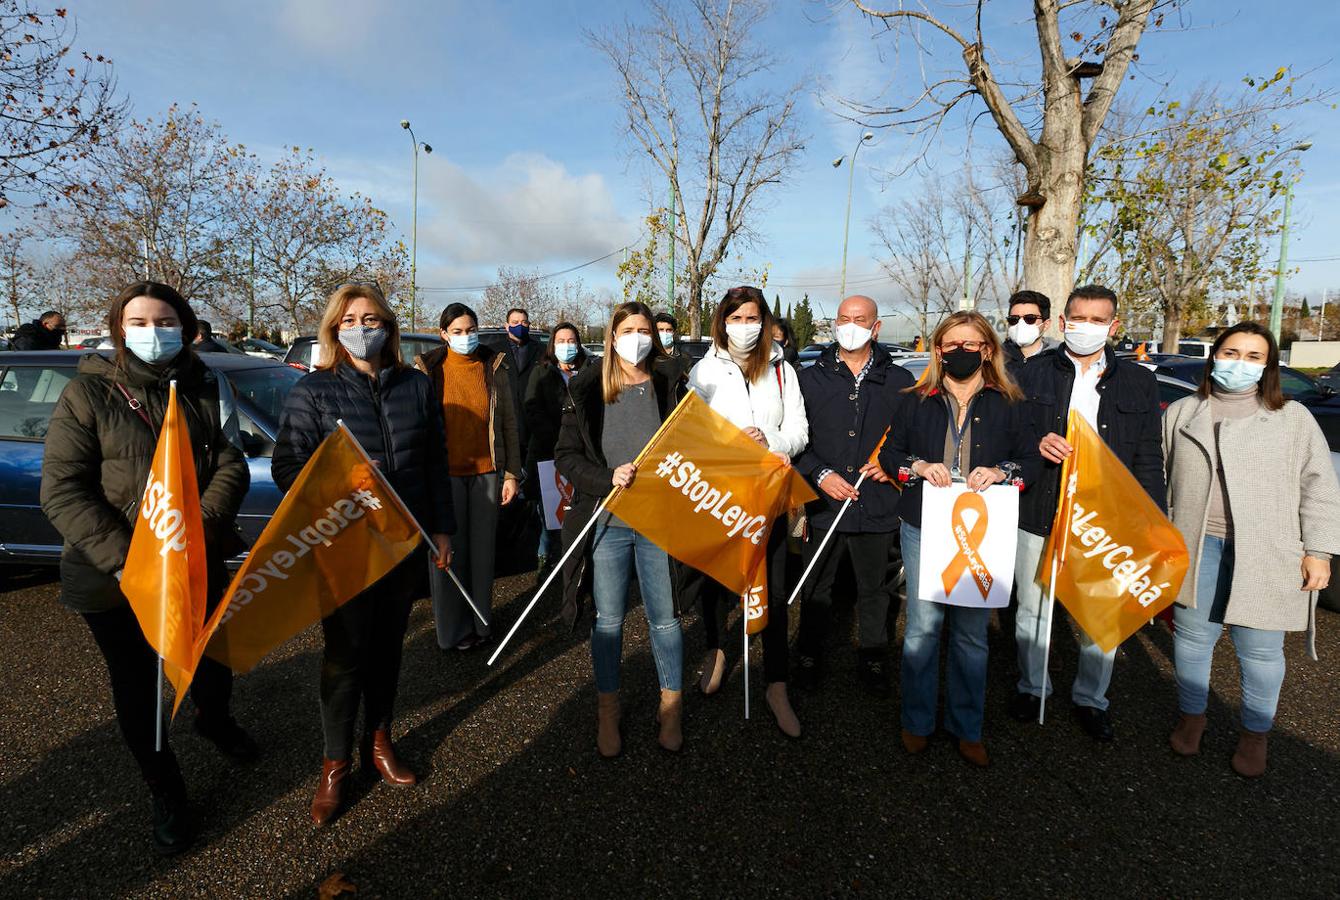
[{"xmin": 55, "ymin": 106, "xmax": 255, "ymax": 300}]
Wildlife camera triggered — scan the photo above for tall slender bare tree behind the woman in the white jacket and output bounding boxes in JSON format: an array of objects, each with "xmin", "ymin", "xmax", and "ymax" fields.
[{"xmin": 588, "ymin": 0, "xmax": 803, "ymax": 338}]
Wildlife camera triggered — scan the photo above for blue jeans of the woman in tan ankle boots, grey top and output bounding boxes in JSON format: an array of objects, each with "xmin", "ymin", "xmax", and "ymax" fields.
[{"xmin": 591, "ymin": 522, "xmax": 683, "ymax": 694}]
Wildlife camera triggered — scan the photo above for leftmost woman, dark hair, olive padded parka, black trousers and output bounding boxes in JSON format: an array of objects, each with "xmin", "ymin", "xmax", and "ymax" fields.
[{"xmin": 42, "ymin": 281, "xmax": 256, "ymax": 853}]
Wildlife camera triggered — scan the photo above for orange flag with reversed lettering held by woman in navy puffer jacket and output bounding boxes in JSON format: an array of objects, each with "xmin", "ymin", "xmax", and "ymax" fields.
[{"xmin": 208, "ymin": 425, "xmax": 422, "ymax": 672}]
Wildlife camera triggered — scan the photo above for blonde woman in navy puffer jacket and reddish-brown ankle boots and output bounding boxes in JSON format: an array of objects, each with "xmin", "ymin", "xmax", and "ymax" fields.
[{"xmin": 271, "ymin": 284, "xmax": 456, "ymax": 826}]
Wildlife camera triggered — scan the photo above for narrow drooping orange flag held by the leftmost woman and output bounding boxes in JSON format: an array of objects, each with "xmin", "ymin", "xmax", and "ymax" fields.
[{"xmin": 121, "ymin": 382, "xmax": 208, "ymax": 715}]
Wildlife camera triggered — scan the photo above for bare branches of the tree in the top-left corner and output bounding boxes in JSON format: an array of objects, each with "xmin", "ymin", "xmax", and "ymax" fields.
[{"xmin": 0, "ymin": 0, "xmax": 123, "ymax": 206}]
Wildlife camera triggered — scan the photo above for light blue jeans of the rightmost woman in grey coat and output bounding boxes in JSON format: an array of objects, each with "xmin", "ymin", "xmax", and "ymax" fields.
[{"xmin": 1173, "ymin": 536, "xmax": 1284, "ymax": 731}]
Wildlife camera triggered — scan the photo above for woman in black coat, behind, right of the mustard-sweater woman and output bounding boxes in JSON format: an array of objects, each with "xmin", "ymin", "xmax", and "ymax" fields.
[{"xmin": 525, "ymin": 321, "xmax": 588, "ymax": 579}]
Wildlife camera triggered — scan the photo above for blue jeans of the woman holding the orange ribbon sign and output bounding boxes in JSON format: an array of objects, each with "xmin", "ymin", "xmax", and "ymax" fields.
[{"xmin": 902, "ymin": 522, "xmax": 992, "ymax": 741}]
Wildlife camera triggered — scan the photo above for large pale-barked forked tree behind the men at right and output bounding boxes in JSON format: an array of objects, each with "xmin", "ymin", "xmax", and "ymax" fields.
[{"xmin": 851, "ymin": 0, "xmax": 1177, "ymax": 305}]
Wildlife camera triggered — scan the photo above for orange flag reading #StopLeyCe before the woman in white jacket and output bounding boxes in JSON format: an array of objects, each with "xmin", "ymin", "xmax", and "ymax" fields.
[{"xmin": 606, "ymin": 394, "xmax": 815, "ymax": 633}]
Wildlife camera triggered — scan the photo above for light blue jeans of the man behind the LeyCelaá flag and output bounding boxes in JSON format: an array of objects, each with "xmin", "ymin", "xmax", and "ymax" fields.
[{"xmin": 1014, "ymin": 529, "xmax": 1116, "ymax": 710}]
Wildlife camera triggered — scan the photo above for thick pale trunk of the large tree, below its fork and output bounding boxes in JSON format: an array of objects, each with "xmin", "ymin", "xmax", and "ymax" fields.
[{"xmin": 1022, "ymin": 154, "xmax": 1084, "ymax": 315}]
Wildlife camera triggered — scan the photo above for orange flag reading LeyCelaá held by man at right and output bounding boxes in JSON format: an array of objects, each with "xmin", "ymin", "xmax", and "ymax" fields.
[{"xmin": 1037, "ymin": 410, "xmax": 1189, "ymax": 651}]
